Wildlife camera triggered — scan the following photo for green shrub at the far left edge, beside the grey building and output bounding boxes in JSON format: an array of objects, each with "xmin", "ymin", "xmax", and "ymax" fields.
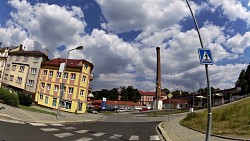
[{"xmin": 0, "ymin": 89, "xmax": 18, "ymax": 107}]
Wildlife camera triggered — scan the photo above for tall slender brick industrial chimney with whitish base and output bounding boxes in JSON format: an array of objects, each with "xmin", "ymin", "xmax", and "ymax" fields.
[{"xmin": 156, "ymin": 47, "xmax": 161, "ymax": 110}]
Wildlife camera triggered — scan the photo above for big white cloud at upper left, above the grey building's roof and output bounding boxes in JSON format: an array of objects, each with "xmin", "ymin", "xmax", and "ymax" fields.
[{"xmin": 9, "ymin": 0, "xmax": 86, "ymax": 55}]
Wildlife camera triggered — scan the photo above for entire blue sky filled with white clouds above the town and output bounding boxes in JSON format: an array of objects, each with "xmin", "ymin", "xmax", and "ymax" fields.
[{"xmin": 0, "ymin": 0, "xmax": 250, "ymax": 92}]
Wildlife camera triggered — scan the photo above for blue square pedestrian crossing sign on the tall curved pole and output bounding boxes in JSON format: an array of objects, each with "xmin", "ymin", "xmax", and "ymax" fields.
[{"xmin": 198, "ymin": 48, "xmax": 214, "ymax": 65}]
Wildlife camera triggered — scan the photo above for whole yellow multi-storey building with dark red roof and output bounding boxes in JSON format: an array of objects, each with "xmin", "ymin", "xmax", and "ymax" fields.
[{"xmin": 35, "ymin": 58, "xmax": 93, "ymax": 113}]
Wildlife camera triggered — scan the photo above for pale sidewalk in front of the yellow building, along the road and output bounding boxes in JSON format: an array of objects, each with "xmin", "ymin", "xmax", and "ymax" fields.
[{"xmin": 0, "ymin": 103, "xmax": 103, "ymax": 123}]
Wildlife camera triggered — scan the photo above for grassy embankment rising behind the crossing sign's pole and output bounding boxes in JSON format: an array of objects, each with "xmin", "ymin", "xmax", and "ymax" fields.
[{"xmin": 180, "ymin": 98, "xmax": 250, "ymax": 138}]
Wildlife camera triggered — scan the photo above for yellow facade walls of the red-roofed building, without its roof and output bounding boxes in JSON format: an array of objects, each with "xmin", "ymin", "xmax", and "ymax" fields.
[{"xmin": 36, "ymin": 60, "xmax": 92, "ymax": 113}]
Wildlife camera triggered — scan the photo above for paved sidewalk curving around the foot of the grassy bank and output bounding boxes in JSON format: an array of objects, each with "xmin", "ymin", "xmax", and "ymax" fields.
[{"xmin": 160, "ymin": 114, "xmax": 231, "ymax": 141}]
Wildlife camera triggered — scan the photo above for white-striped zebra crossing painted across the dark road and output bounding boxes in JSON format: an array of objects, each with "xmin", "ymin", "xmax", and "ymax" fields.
[{"xmin": 29, "ymin": 123, "xmax": 160, "ymax": 141}]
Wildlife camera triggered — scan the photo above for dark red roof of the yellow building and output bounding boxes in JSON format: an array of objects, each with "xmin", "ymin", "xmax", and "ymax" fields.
[{"xmin": 42, "ymin": 58, "xmax": 93, "ymax": 70}]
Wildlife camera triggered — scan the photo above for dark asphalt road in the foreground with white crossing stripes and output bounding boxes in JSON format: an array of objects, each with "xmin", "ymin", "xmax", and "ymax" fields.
[{"xmin": 0, "ymin": 118, "xmax": 160, "ymax": 141}]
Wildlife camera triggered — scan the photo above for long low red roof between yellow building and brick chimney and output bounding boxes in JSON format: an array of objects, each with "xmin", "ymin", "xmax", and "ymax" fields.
[{"xmin": 93, "ymin": 100, "xmax": 141, "ymax": 106}]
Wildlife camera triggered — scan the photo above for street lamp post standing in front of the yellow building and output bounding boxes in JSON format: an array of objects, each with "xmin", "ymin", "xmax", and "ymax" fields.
[{"xmin": 56, "ymin": 46, "xmax": 83, "ymax": 119}]
